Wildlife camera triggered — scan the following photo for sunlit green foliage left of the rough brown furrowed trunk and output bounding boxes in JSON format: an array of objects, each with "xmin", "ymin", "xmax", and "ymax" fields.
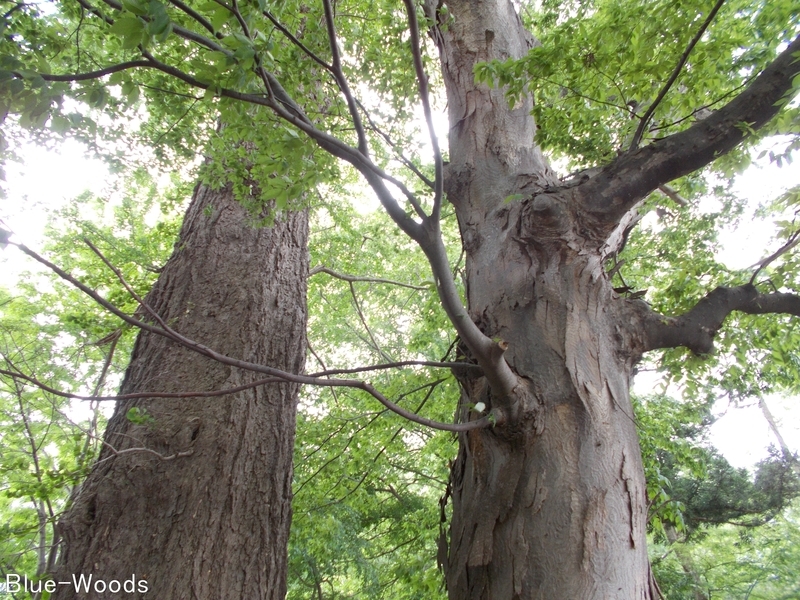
[{"xmin": 0, "ymin": 172, "xmax": 181, "ymax": 592}]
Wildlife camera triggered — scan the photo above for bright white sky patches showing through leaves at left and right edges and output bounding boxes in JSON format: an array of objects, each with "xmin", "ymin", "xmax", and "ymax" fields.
[{"xmin": 0, "ymin": 135, "xmax": 800, "ymax": 466}]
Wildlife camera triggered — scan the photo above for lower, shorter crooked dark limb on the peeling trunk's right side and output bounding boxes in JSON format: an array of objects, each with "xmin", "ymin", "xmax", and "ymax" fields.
[{"xmin": 636, "ymin": 283, "xmax": 800, "ymax": 354}]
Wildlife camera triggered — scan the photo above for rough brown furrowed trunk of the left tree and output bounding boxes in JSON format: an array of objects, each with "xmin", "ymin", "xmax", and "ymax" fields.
[{"xmin": 50, "ymin": 180, "xmax": 308, "ymax": 600}]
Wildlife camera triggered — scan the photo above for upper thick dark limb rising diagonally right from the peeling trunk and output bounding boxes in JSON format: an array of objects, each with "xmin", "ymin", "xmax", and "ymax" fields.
[{"xmin": 578, "ymin": 36, "xmax": 800, "ymax": 228}]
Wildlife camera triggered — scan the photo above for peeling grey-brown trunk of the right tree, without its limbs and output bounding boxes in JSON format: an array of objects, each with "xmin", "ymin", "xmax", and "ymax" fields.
[{"xmin": 440, "ymin": 0, "xmax": 658, "ymax": 600}]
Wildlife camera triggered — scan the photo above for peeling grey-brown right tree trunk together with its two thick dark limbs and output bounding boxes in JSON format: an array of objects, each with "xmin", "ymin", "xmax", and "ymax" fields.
[{"xmin": 429, "ymin": 0, "xmax": 800, "ymax": 600}]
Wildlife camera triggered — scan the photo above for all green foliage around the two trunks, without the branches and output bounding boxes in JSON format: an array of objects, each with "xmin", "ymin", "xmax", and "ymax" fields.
[{"xmin": 0, "ymin": 0, "xmax": 800, "ymax": 599}]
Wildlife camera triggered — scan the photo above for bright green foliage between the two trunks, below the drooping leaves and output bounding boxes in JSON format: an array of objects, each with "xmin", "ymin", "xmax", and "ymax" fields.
[{"xmin": 288, "ymin": 196, "xmax": 459, "ymax": 600}]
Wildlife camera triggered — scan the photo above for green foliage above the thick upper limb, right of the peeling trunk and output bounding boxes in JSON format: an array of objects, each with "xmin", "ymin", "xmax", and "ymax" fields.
[{"xmin": 476, "ymin": 0, "xmax": 800, "ymax": 168}]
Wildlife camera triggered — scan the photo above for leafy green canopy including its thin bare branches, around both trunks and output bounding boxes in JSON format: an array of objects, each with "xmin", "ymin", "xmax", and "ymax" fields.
[{"xmin": 0, "ymin": 0, "xmax": 800, "ymax": 598}]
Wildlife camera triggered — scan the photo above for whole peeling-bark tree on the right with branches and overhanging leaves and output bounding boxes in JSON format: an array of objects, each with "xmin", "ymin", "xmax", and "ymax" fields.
[{"xmin": 4, "ymin": 0, "xmax": 800, "ymax": 598}]
